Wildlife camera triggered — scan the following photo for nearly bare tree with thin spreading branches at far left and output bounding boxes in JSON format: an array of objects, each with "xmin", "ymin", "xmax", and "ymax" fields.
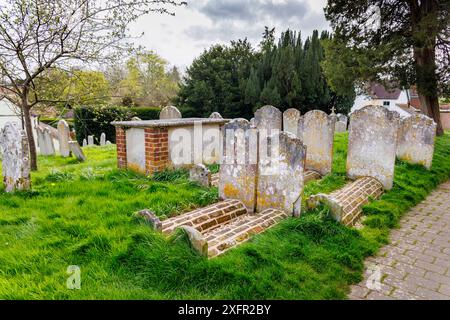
[{"xmin": 0, "ymin": 0, "xmax": 186, "ymax": 170}]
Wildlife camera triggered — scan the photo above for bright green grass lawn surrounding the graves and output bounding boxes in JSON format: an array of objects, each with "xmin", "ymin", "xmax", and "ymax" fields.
[{"xmin": 0, "ymin": 134, "xmax": 450, "ymax": 299}]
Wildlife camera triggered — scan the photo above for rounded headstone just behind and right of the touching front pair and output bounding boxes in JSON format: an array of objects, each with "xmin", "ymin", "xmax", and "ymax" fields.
[{"xmin": 298, "ymin": 110, "xmax": 336, "ymax": 176}]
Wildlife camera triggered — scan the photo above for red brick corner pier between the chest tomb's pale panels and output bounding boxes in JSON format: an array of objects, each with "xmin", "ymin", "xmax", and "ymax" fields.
[{"xmin": 145, "ymin": 128, "xmax": 169, "ymax": 174}]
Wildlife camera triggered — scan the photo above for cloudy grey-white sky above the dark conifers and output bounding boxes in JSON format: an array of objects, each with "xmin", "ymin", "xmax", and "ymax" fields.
[{"xmin": 131, "ymin": 0, "xmax": 329, "ymax": 68}]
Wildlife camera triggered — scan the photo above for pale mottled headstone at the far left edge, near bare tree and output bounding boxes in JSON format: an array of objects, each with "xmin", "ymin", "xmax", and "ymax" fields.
[{"xmin": 0, "ymin": 122, "xmax": 31, "ymax": 192}]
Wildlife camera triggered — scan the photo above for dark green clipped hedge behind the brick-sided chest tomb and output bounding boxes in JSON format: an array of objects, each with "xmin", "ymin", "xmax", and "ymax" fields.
[{"xmin": 75, "ymin": 106, "xmax": 160, "ymax": 144}]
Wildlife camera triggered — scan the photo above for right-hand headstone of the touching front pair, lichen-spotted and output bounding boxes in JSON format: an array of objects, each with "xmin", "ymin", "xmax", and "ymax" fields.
[{"xmin": 256, "ymin": 132, "xmax": 306, "ymax": 216}]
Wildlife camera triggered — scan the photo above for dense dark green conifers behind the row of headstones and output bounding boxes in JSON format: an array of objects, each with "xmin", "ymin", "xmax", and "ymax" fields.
[{"xmin": 175, "ymin": 27, "xmax": 355, "ymax": 119}]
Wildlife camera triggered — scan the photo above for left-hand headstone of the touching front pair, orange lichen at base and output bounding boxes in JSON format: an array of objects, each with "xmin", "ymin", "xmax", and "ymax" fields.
[{"xmin": 219, "ymin": 119, "xmax": 258, "ymax": 212}]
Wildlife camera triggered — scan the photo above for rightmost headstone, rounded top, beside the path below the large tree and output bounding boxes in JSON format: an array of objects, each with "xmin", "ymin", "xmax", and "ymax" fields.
[{"xmin": 397, "ymin": 114, "xmax": 436, "ymax": 169}]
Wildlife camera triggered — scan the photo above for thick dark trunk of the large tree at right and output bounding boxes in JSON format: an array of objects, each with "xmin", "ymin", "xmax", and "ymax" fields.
[{"xmin": 414, "ymin": 47, "xmax": 444, "ymax": 136}]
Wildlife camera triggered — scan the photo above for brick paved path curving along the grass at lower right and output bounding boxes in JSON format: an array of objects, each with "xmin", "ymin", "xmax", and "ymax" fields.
[{"xmin": 349, "ymin": 180, "xmax": 450, "ymax": 300}]
